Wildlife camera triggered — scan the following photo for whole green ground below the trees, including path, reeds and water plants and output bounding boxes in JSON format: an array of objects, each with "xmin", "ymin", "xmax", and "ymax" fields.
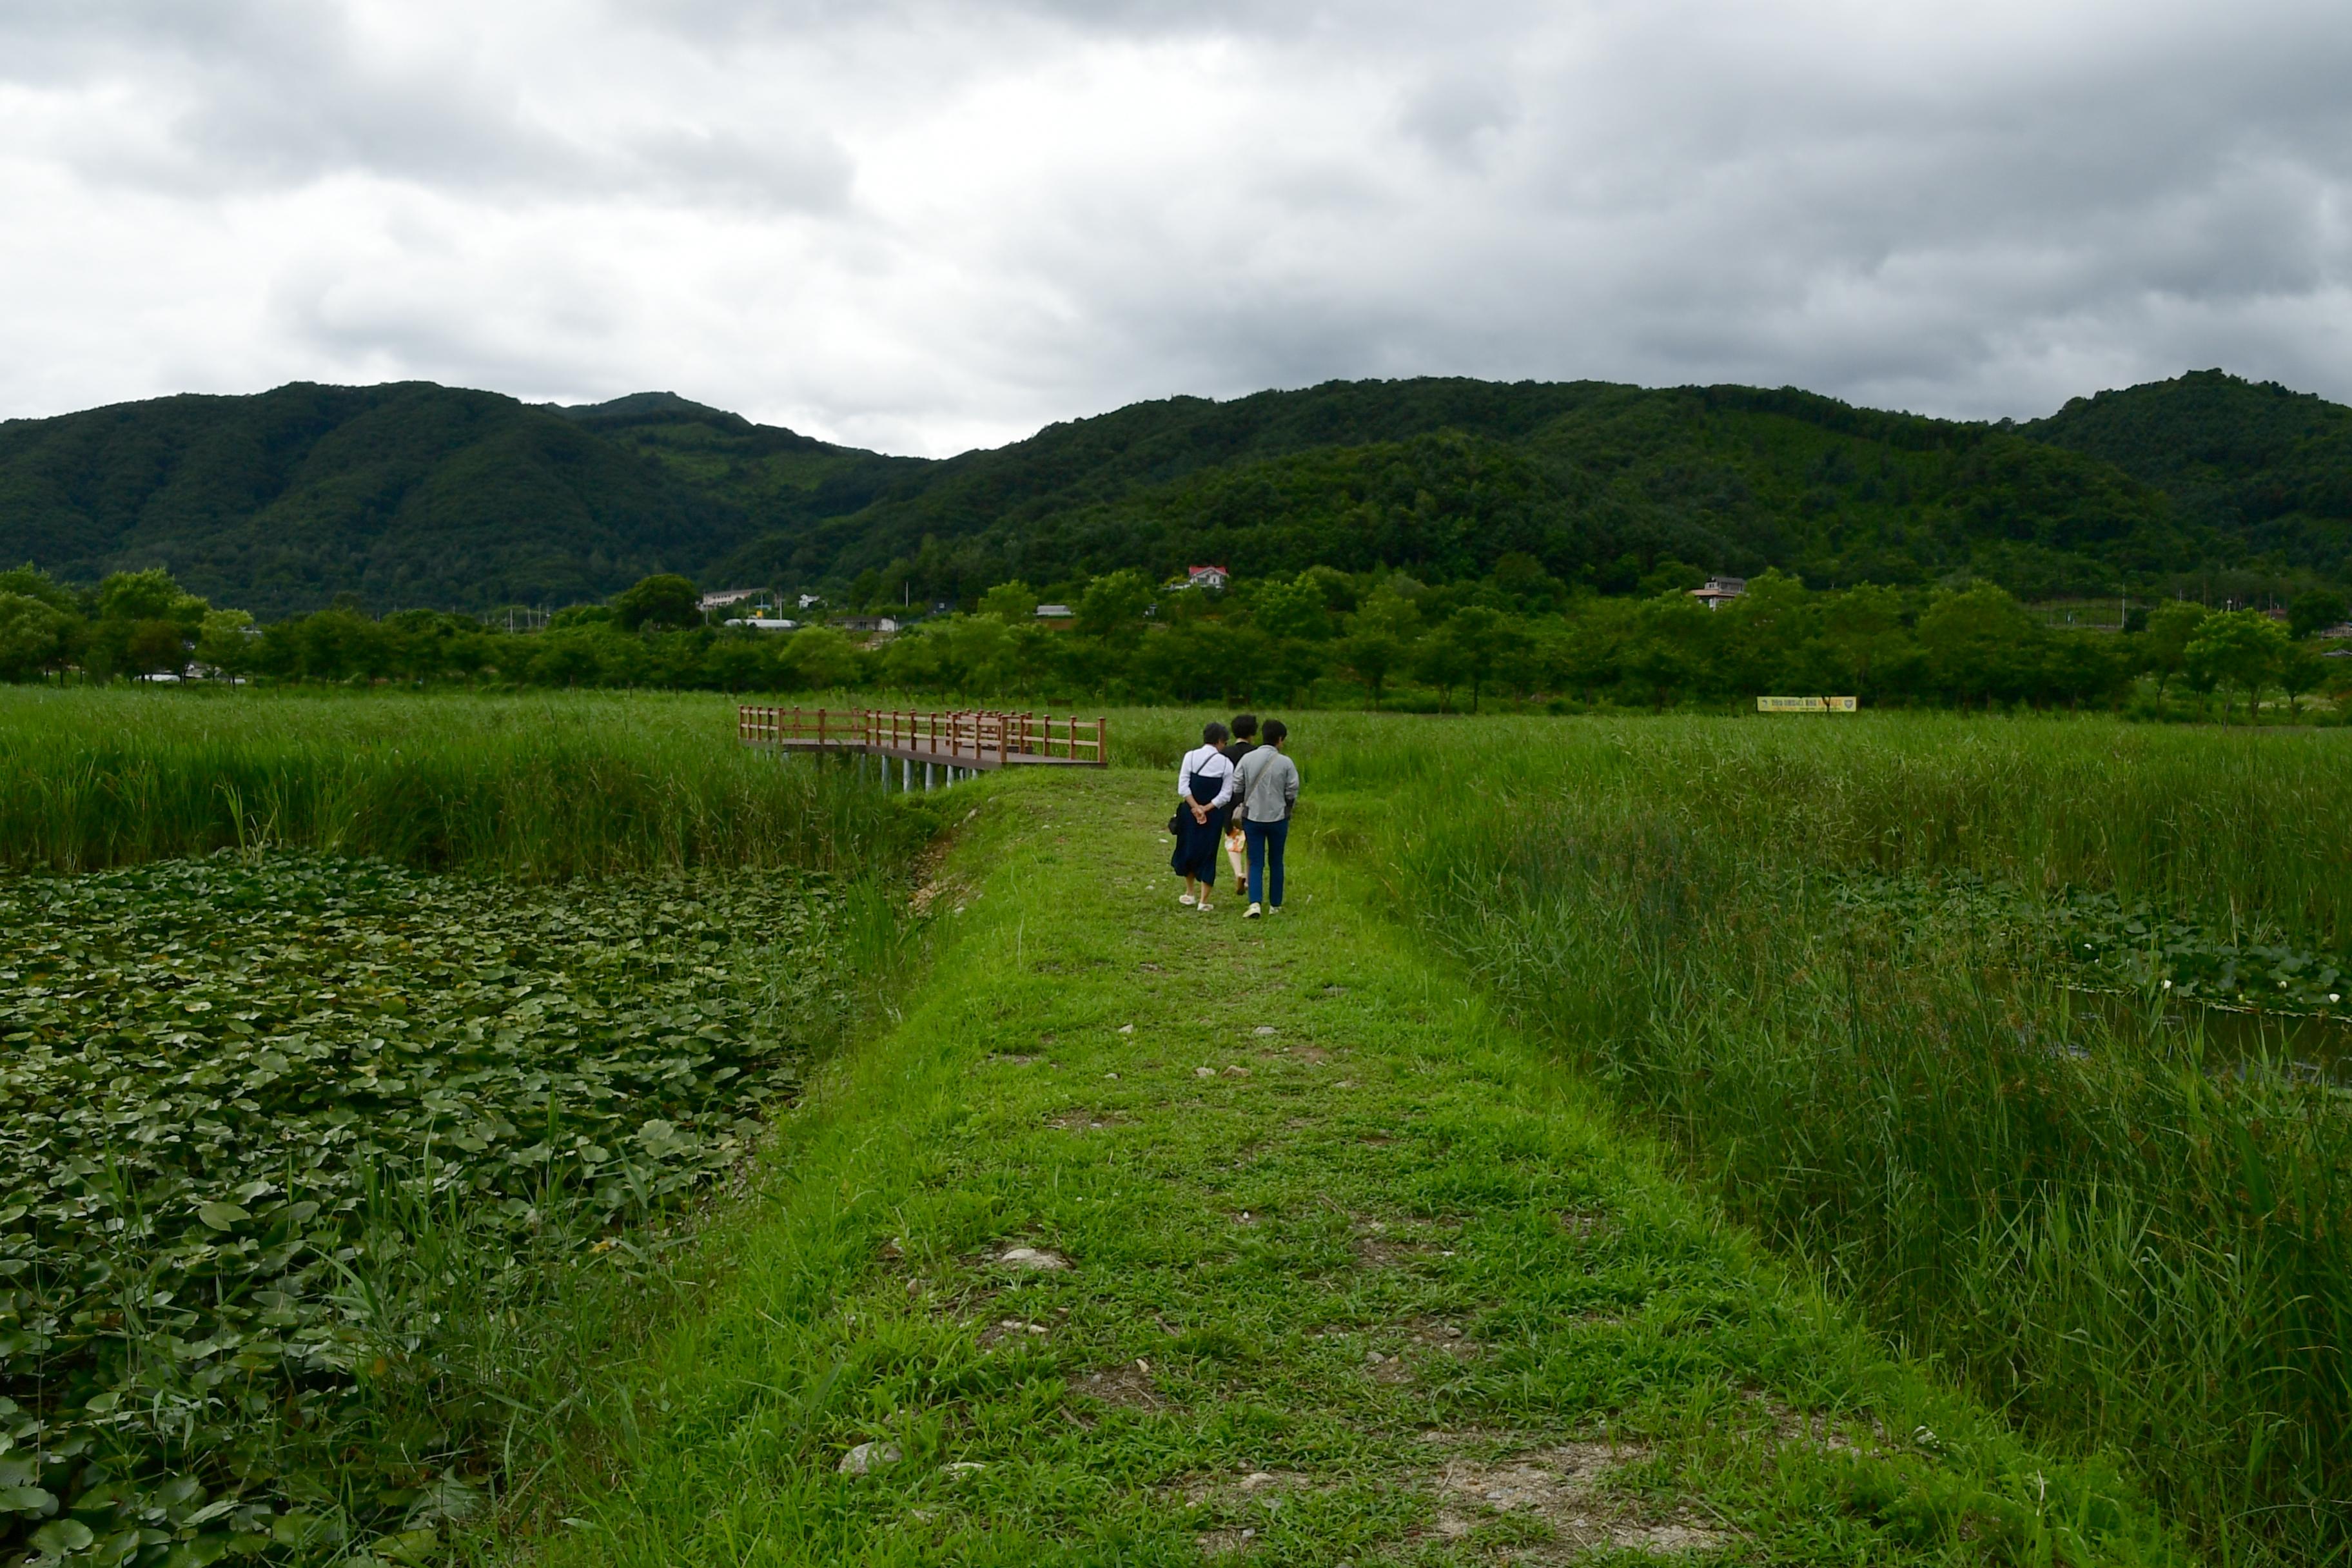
[{"xmin": 0, "ymin": 691, "xmax": 2352, "ymax": 1563}]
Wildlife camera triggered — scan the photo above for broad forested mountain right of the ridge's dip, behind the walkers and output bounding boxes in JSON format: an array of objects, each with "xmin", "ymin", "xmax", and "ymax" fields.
[{"xmin": 767, "ymin": 381, "xmax": 2199, "ymax": 597}]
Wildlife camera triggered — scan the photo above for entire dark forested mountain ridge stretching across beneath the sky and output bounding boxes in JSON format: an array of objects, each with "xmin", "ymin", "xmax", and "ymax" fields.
[{"xmin": 0, "ymin": 371, "xmax": 2352, "ymax": 616}]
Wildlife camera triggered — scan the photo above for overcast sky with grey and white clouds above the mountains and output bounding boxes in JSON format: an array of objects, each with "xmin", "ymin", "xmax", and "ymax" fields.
[{"xmin": 0, "ymin": 0, "xmax": 2352, "ymax": 454}]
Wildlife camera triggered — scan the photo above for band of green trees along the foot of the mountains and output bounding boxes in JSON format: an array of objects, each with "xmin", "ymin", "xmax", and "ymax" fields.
[{"xmin": 0, "ymin": 554, "xmax": 2352, "ymax": 720}]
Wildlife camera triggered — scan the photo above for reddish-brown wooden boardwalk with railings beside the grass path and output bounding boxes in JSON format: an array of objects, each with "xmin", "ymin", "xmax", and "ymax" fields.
[{"xmin": 736, "ymin": 705, "xmax": 1110, "ymax": 790}]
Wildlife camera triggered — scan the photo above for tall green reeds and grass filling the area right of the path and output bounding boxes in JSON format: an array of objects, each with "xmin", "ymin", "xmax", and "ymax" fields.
[{"xmin": 1322, "ymin": 717, "xmax": 2352, "ymax": 1563}]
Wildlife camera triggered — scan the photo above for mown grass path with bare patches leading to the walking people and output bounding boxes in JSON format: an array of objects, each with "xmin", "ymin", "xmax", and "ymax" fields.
[{"xmin": 541, "ymin": 774, "xmax": 2173, "ymax": 1565}]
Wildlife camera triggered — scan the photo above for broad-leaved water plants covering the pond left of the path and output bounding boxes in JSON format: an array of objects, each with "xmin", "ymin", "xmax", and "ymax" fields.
[{"xmin": 0, "ymin": 854, "xmax": 847, "ymax": 1563}]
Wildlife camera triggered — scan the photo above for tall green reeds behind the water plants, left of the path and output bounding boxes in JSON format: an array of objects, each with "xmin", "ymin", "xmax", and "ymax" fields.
[{"xmin": 0, "ymin": 687, "xmax": 932, "ymax": 879}]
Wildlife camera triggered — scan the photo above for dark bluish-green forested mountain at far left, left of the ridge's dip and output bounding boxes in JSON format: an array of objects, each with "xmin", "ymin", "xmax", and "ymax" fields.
[{"xmin": 0, "ymin": 383, "xmax": 750, "ymax": 614}]
